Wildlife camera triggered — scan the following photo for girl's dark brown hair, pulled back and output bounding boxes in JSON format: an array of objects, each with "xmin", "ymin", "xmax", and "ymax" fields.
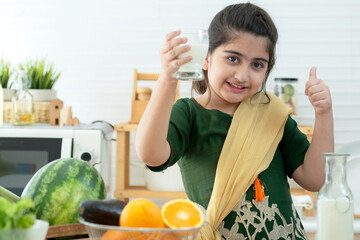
[{"xmin": 192, "ymin": 3, "xmax": 278, "ymax": 97}]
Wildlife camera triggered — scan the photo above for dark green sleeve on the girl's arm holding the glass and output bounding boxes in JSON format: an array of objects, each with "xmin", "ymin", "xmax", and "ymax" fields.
[{"xmin": 148, "ymin": 99, "xmax": 191, "ymax": 172}]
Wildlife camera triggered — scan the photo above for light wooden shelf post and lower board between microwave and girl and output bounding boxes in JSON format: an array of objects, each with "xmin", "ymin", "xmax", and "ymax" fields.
[{"xmin": 114, "ymin": 123, "xmax": 187, "ymax": 202}]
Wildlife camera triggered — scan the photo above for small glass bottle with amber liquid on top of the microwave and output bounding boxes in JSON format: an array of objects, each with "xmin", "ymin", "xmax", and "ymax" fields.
[{"xmin": 12, "ymin": 71, "xmax": 35, "ymax": 126}]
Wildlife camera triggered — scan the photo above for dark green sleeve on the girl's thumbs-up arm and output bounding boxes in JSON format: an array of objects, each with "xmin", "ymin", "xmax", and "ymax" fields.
[{"xmin": 279, "ymin": 116, "xmax": 310, "ymax": 177}]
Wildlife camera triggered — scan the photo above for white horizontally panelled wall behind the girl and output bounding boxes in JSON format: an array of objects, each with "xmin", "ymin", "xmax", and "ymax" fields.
[{"xmin": 0, "ymin": 0, "xmax": 360, "ymax": 188}]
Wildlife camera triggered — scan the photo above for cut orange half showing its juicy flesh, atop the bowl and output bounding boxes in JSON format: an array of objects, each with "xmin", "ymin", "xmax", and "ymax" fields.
[{"xmin": 161, "ymin": 199, "xmax": 204, "ymax": 228}]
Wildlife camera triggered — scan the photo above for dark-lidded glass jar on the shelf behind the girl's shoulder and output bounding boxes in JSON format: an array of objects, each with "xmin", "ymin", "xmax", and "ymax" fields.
[{"xmin": 274, "ymin": 78, "xmax": 298, "ymax": 115}]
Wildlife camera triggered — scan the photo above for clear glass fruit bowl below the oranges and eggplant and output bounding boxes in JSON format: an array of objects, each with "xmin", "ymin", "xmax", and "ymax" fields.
[{"xmin": 80, "ymin": 219, "xmax": 207, "ymax": 240}]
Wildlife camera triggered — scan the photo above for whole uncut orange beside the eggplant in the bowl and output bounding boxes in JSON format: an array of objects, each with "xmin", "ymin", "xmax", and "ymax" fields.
[{"xmin": 120, "ymin": 198, "xmax": 164, "ymax": 228}]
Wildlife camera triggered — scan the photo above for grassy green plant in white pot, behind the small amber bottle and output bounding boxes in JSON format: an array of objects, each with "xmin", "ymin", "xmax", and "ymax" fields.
[{"xmin": 19, "ymin": 59, "xmax": 61, "ymax": 102}]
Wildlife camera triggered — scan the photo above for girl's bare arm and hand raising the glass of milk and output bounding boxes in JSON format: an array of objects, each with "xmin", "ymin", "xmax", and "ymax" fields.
[{"xmin": 135, "ymin": 30, "xmax": 192, "ymax": 166}]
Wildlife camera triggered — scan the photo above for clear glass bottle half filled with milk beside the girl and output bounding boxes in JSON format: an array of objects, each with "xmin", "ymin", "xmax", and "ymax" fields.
[{"xmin": 316, "ymin": 153, "xmax": 354, "ymax": 240}]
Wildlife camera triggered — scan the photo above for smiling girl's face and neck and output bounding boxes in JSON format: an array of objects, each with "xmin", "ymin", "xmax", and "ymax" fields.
[{"xmin": 204, "ymin": 33, "xmax": 269, "ymax": 110}]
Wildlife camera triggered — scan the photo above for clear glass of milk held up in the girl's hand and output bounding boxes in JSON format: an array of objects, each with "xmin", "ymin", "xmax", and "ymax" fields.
[{"xmin": 176, "ymin": 29, "xmax": 209, "ymax": 81}]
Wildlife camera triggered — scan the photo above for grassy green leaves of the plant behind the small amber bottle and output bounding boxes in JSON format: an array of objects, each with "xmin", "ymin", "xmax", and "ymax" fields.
[{"xmin": 19, "ymin": 59, "xmax": 61, "ymax": 89}]
